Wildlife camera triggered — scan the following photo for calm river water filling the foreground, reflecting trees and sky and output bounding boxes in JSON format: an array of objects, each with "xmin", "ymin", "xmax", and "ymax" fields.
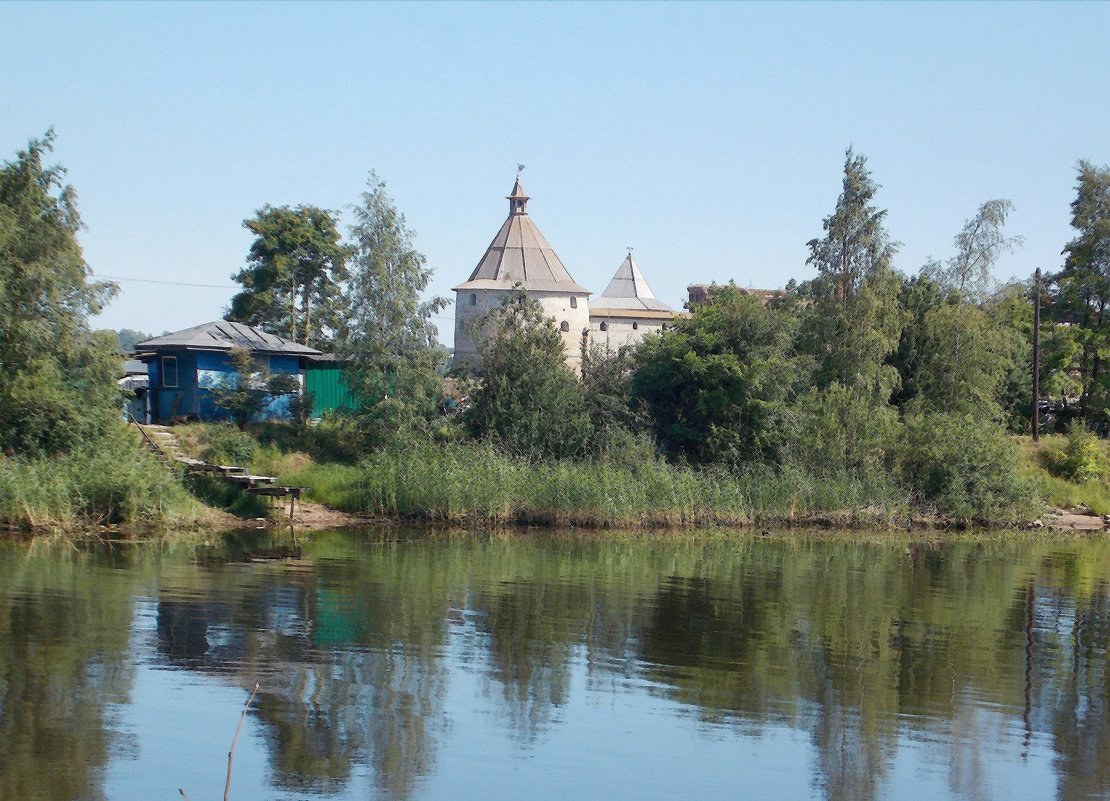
[{"xmin": 0, "ymin": 531, "xmax": 1110, "ymax": 801}]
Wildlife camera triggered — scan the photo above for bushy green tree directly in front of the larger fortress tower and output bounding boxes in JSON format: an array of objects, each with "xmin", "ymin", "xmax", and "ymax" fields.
[{"xmin": 467, "ymin": 288, "xmax": 592, "ymax": 458}]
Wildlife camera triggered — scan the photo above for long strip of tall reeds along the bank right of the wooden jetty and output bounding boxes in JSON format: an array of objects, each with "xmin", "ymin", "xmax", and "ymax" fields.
[{"xmin": 280, "ymin": 443, "xmax": 901, "ymax": 527}]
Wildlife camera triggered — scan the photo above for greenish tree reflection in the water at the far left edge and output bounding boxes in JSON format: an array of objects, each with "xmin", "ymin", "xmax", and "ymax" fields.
[{"xmin": 0, "ymin": 549, "xmax": 133, "ymax": 801}]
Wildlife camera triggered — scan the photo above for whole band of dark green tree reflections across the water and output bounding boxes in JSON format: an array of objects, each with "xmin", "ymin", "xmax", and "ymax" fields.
[{"xmin": 0, "ymin": 534, "xmax": 1110, "ymax": 801}]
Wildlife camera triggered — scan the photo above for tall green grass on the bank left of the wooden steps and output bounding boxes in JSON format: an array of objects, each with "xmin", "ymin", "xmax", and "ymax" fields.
[{"xmin": 0, "ymin": 432, "xmax": 205, "ymax": 530}]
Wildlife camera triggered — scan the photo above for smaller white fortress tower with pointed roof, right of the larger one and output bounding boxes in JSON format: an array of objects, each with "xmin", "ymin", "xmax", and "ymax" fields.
[{"xmin": 589, "ymin": 250, "xmax": 676, "ymax": 351}]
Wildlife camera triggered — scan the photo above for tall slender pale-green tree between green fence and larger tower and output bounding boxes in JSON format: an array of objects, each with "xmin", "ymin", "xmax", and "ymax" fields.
[{"xmin": 340, "ymin": 171, "xmax": 447, "ymax": 437}]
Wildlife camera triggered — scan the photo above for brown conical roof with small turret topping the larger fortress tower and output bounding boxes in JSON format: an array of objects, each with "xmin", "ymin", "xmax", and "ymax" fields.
[{"xmin": 455, "ymin": 175, "xmax": 589, "ymax": 295}]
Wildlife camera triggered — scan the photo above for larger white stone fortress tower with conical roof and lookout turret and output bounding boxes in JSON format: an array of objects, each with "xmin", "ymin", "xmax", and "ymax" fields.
[{"xmin": 452, "ymin": 175, "xmax": 591, "ymax": 369}]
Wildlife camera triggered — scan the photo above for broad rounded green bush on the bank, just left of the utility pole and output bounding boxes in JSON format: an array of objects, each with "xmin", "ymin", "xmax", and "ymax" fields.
[{"xmin": 896, "ymin": 412, "xmax": 1035, "ymax": 523}]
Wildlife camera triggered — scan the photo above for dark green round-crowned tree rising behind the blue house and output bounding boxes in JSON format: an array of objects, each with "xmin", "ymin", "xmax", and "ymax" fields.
[{"xmin": 228, "ymin": 205, "xmax": 347, "ymax": 347}]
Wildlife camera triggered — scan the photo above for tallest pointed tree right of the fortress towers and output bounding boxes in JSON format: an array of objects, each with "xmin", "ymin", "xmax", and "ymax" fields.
[{"xmin": 804, "ymin": 148, "xmax": 904, "ymax": 394}]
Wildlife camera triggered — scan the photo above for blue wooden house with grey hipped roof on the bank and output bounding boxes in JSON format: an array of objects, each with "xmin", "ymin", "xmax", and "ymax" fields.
[{"xmin": 135, "ymin": 320, "xmax": 322, "ymax": 423}]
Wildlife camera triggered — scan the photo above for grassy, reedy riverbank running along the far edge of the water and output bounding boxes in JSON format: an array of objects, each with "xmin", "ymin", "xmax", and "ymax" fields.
[{"xmin": 0, "ymin": 425, "xmax": 1110, "ymax": 531}]
